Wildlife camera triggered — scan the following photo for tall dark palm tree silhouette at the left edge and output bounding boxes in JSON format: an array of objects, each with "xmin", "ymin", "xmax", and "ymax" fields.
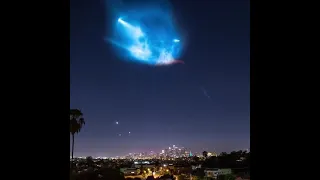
[{"xmin": 70, "ymin": 109, "xmax": 85, "ymax": 164}]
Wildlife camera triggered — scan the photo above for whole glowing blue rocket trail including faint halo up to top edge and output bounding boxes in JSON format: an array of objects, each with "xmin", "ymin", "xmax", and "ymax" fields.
[{"xmin": 106, "ymin": 0, "xmax": 184, "ymax": 66}]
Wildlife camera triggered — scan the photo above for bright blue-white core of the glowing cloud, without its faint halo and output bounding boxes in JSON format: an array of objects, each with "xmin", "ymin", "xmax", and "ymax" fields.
[{"xmin": 108, "ymin": 18, "xmax": 181, "ymax": 65}]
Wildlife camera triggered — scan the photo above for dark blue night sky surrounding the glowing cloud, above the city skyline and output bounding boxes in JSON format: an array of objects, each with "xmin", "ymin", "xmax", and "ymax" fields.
[{"xmin": 70, "ymin": 0, "xmax": 250, "ymax": 156}]
